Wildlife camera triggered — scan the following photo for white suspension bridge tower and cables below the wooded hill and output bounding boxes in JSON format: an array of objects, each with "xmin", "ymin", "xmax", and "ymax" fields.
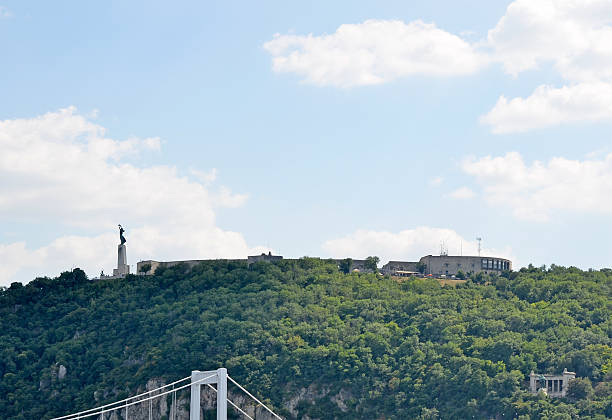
[{"xmin": 51, "ymin": 368, "xmax": 283, "ymax": 420}]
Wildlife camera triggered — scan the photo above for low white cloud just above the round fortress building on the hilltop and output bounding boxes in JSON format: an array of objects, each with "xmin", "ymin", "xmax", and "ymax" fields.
[{"xmin": 323, "ymin": 226, "xmax": 513, "ymax": 262}]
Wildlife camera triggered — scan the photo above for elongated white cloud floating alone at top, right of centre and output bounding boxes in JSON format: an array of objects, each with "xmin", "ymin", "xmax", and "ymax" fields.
[{"xmin": 264, "ymin": 20, "xmax": 486, "ymax": 87}]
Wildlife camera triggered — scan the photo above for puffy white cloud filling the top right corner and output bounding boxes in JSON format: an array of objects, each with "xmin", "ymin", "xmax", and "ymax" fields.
[{"xmin": 487, "ymin": 0, "xmax": 612, "ymax": 81}]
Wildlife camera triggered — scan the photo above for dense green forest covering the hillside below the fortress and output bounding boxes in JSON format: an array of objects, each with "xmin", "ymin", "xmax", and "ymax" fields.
[{"xmin": 0, "ymin": 258, "xmax": 612, "ymax": 420}]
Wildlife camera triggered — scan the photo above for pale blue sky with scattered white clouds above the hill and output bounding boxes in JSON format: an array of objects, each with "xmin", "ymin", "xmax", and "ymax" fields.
[{"xmin": 0, "ymin": 0, "xmax": 612, "ymax": 286}]
